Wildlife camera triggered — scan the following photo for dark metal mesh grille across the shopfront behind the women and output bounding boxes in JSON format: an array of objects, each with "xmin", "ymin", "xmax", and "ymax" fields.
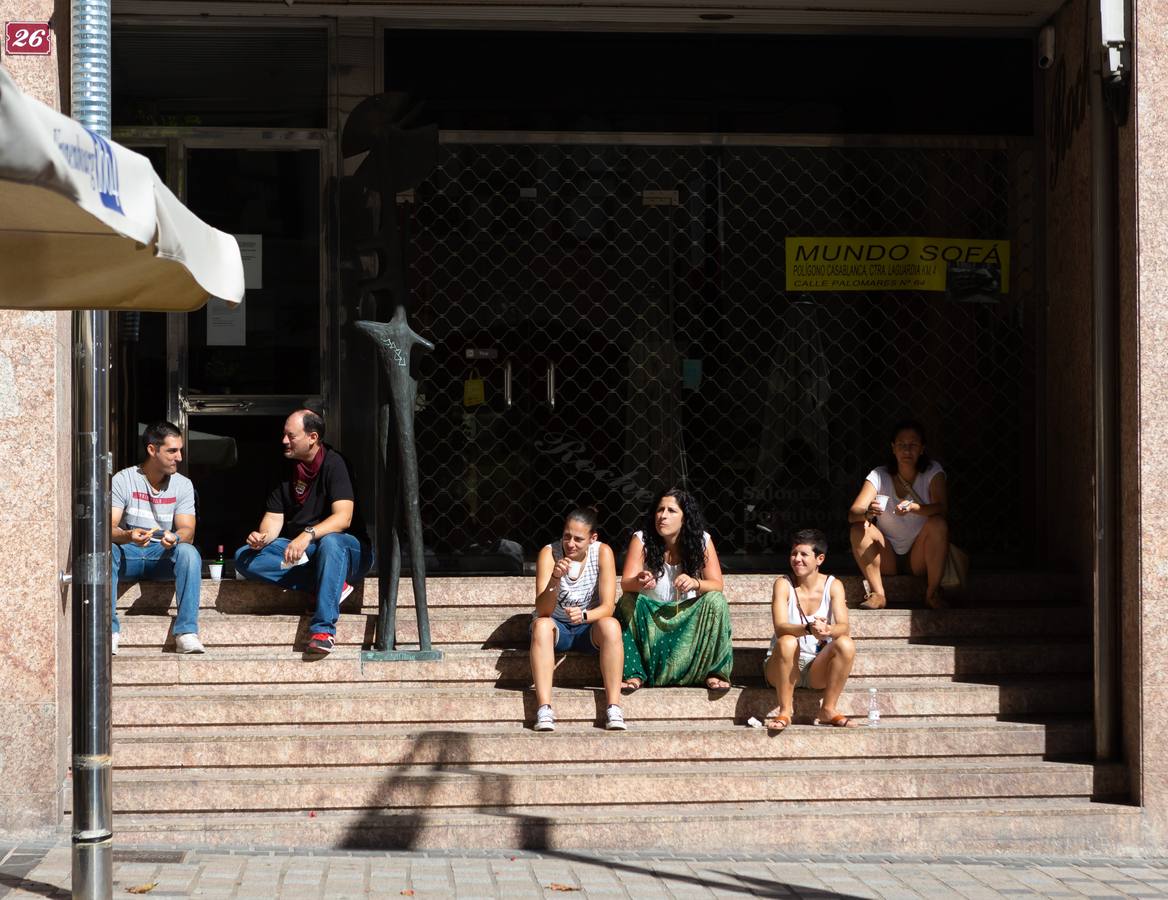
[{"xmin": 399, "ymin": 142, "xmax": 1033, "ymax": 561}]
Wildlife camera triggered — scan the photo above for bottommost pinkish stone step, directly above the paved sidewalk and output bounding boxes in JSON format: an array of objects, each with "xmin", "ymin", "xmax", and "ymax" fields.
[{"xmin": 102, "ymin": 797, "xmax": 1142, "ymax": 856}]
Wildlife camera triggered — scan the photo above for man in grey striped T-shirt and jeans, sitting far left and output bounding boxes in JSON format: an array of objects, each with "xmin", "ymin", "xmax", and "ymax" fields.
[{"xmin": 110, "ymin": 421, "xmax": 203, "ymax": 654}]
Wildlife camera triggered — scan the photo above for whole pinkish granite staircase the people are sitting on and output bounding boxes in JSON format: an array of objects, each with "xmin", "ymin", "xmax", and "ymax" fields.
[{"xmin": 93, "ymin": 575, "xmax": 1139, "ymax": 853}]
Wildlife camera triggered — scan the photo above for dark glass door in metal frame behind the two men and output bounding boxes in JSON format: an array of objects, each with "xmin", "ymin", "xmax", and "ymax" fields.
[{"xmin": 167, "ymin": 137, "xmax": 331, "ymax": 556}]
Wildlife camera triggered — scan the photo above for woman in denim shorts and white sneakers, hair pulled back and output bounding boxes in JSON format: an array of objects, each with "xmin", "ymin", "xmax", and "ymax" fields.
[{"xmin": 530, "ymin": 507, "xmax": 625, "ymax": 731}]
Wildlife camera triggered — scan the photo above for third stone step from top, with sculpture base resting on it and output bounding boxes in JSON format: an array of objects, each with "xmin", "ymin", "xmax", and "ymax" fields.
[{"xmin": 105, "ymin": 640, "xmax": 1091, "ymax": 685}]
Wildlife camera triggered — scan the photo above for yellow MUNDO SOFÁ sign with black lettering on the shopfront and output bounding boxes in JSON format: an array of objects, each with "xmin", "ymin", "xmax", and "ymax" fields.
[{"xmin": 786, "ymin": 237, "xmax": 1010, "ymax": 294}]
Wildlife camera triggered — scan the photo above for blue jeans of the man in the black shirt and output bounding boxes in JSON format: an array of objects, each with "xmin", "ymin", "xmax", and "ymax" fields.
[{"xmin": 235, "ymin": 533, "xmax": 373, "ymax": 635}]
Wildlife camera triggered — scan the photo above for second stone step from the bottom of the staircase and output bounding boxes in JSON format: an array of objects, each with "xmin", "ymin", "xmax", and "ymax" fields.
[{"xmin": 102, "ymin": 761, "xmax": 1126, "ymax": 814}]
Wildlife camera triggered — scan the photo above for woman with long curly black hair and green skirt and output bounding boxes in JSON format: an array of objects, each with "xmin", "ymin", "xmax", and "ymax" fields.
[{"xmin": 617, "ymin": 488, "xmax": 734, "ymax": 692}]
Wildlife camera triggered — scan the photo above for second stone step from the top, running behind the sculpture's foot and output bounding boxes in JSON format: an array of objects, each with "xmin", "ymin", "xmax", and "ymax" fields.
[{"xmin": 111, "ymin": 604, "xmax": 1086, "ymax": 648}]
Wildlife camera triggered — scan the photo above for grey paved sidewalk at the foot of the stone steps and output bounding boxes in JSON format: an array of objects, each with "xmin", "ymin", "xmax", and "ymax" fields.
[{"xmin": 0, "ymin": 845, "xmax": 1168, "ymax": 900}]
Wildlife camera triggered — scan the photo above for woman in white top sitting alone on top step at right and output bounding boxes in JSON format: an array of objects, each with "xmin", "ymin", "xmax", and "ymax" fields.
[{"xmin": 848, "ymin": 420, "xmax": 948, "ymax": 609}]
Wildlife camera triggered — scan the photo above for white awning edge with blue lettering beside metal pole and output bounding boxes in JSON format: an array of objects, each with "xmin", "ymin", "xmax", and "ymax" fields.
[{"xmin": 0, "ymin": 67, "xmax": 243, "ymax": 312}]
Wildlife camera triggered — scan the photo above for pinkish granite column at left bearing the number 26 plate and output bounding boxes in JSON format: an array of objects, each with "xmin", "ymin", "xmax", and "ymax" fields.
[{"xmin": 0, "ymin": 0, "xmax": 70, "ymax": 836}]
